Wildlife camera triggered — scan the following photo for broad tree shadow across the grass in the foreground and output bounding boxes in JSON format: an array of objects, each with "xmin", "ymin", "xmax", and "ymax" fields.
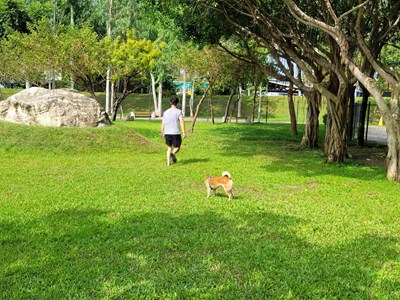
[{"xmin": 0, "ymin": 207, "xmax": 400, "ymax": 299}]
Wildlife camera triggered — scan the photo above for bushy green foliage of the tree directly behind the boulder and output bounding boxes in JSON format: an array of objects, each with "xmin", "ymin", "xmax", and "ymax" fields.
[{"xmin": 0, "ymin": 20, "xmax": 107, "ymax": 98}]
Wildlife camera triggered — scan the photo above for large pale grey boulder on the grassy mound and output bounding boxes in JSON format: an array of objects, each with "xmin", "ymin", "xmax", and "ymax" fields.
[{"xmin": 0, "ymin": 87, "xmax": 101, "ymax": 127}]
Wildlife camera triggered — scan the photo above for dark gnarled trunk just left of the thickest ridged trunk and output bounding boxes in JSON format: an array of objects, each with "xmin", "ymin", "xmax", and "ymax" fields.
[{"xmin": 301, "ymin": 91, "xmax": 321, "ymax": 149}]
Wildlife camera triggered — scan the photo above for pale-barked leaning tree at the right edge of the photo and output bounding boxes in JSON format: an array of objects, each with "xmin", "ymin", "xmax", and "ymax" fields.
[{"xmin": 284, "ymin": 0, "xmax": 400, "ymax": 181}]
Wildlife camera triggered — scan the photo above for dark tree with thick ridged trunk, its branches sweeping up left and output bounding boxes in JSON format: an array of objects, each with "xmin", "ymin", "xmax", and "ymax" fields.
[{"xmin": 212, "ymin": 0, "xmax": 360, "ymax": 162}]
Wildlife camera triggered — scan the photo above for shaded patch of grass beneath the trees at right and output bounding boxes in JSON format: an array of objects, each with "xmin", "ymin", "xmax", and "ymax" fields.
[{"xmin": 212, "ymin": 124, "xmax": 387, "ymax": 181}]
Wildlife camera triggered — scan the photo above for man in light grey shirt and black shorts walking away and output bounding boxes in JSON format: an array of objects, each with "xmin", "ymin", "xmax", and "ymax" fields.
[{"xmin": 161, "ymin": 97, "xmax": 186, "ymax": 166}]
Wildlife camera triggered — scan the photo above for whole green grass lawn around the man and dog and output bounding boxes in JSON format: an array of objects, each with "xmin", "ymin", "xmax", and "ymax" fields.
[{"xmin": 0, "ymin": 121, "xmax": 400, "ymax": 299}]
